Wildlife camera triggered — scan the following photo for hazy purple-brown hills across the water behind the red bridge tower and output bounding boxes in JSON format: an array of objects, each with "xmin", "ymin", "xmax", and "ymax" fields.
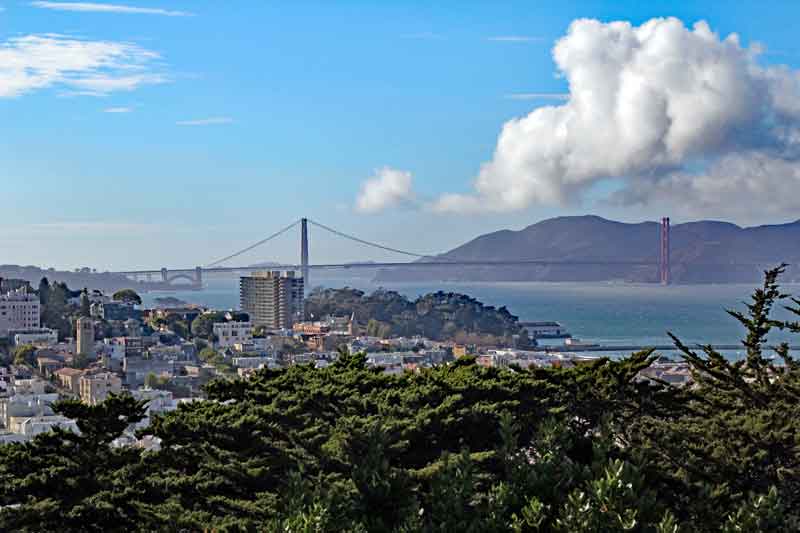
[{"xmin": 378, "ymin": 215, "xmax": 800, "ymax": 283}]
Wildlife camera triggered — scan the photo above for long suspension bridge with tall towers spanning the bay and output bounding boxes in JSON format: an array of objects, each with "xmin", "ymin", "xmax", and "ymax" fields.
[{"xmin": 115, "ymin": 218, "xmax": 688, "ymax": 287}]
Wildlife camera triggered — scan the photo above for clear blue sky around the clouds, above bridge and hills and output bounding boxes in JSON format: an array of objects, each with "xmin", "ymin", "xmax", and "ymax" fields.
[{"xmin": 0, "ymin": 0, "xmax": 800, "ymax": 269}]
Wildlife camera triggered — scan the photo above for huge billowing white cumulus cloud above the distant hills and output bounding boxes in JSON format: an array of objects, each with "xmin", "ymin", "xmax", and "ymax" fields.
[{"xmin": 432, "ymin": 18, "xmax": 800, "ymax": 214}]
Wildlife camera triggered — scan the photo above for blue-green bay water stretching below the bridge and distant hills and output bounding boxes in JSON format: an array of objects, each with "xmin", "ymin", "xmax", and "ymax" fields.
[{"xmin": 139, "ymin": 278, "xmax": 800, "ymax": 354}]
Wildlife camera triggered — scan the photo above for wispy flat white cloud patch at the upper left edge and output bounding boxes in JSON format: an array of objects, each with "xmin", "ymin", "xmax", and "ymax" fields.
[{"xmin": 0, "ymin": 34, "xmax": 167, "ymax": 98}]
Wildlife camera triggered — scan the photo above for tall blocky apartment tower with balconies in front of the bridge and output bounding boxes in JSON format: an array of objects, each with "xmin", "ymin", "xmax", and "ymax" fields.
[{"xmin": 239, "ymin": 271, "xmax": 304, "ymax": 329}]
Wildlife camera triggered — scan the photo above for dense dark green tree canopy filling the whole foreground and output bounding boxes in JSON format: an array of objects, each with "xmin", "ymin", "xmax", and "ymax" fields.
[{"xmin": 0, "ymin": 269, "xmax": 800, "ymax": 533}]
